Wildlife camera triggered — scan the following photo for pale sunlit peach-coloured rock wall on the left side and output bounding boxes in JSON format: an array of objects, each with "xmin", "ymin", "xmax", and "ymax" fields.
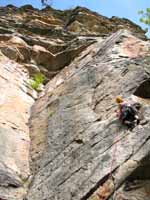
[{"xmin": 0, "ymin": 53, "xmax": 34, "ymax": 200}]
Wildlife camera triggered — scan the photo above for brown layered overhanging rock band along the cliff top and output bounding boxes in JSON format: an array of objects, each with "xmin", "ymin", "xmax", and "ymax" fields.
[{"xmin": 0, "ymin": 5, "xmax": 145, "ymax": 82}]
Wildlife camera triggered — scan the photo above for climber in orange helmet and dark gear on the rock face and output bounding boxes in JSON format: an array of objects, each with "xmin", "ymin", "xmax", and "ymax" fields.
[{"xmin": 116, "ymin": 96, "xmax": 140, "ymax": 128}]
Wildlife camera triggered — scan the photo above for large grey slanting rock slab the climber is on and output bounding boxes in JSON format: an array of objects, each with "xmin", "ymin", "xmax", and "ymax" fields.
[{"xmin": 27, "ymin": 31, "xmax": 150, "ymax": 200}]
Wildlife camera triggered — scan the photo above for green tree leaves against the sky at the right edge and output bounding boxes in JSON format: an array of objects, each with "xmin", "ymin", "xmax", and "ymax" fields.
[{"xmin": 138, "ymin": 8, "xmax": 150, "ymax": 31}]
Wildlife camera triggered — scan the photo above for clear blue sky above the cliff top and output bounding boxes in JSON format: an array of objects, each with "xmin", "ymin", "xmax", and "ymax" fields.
[{"xmin": 0, "ymin": 0, "xmax": 150, "ymax": 31}]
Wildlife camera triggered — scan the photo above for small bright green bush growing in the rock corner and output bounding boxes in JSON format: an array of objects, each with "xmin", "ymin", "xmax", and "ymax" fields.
[{"xmin": 29, "ymin": 73, "xmax": 45, "ymax": 90}]
